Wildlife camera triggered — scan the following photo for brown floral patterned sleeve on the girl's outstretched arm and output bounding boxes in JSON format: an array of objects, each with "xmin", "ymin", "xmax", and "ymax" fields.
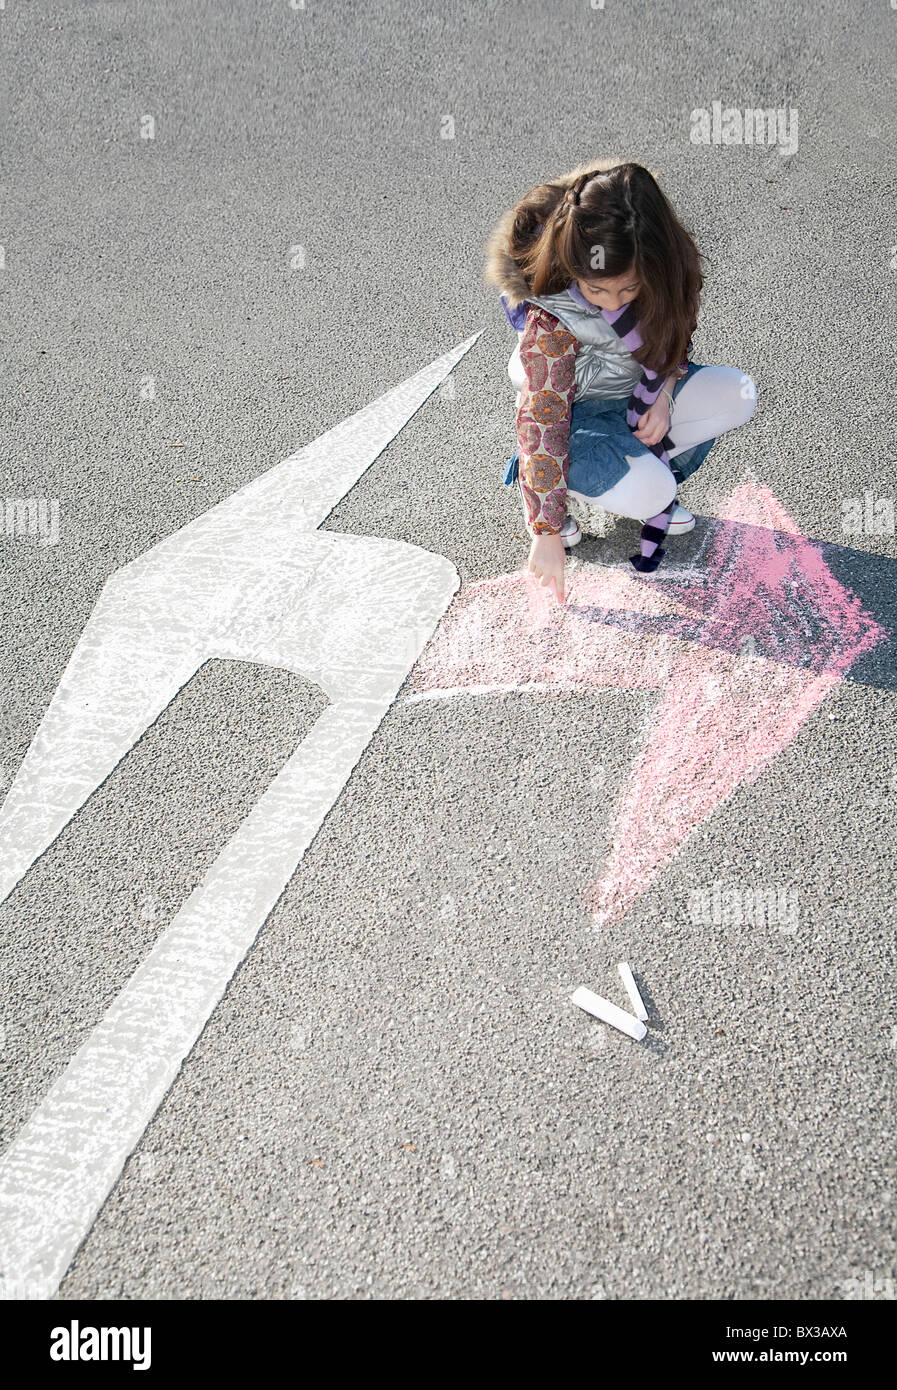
[{"xmin": 517, "ymin": 304, "xmax": 580, "ymax": 535}]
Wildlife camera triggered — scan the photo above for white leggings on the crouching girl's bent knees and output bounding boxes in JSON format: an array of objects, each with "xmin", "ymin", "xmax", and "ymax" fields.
[{"xmin": 595, "ymin": 367, "xmax": 757, "ymax": 521}]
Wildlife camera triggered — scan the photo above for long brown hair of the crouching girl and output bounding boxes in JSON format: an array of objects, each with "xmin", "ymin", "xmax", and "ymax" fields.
[{"xmin": 497, "ymin": 164, "xmax": 704, "ymax": 373}]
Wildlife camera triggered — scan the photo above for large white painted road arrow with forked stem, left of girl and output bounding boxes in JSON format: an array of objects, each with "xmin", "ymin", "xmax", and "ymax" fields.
[{"xmin": 0, "ymin": 334, "xmax": 480, "ymax": 1298}]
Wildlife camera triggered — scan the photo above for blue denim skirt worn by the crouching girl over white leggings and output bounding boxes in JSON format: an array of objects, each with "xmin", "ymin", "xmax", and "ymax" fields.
[{"xmin": 502, "ymin": 361, "xmax": 716, "ymax": 498}]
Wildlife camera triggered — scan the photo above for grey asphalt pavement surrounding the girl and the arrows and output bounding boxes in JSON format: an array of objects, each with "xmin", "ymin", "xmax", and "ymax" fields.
[{"xmin": 0, "ymin": 0, "xmax": 897, "ymax": 1300}]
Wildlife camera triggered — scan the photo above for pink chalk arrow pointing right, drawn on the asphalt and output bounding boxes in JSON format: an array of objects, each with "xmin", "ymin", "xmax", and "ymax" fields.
[{"xmin": 410, "ymin": 482, "xmax": 889, "ymax": 927}]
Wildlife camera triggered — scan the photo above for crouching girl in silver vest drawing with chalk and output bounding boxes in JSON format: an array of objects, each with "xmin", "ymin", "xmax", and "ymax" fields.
[{"xmin": 485, "ymin": 160, "xmax": 757, "ymax": 602}]
